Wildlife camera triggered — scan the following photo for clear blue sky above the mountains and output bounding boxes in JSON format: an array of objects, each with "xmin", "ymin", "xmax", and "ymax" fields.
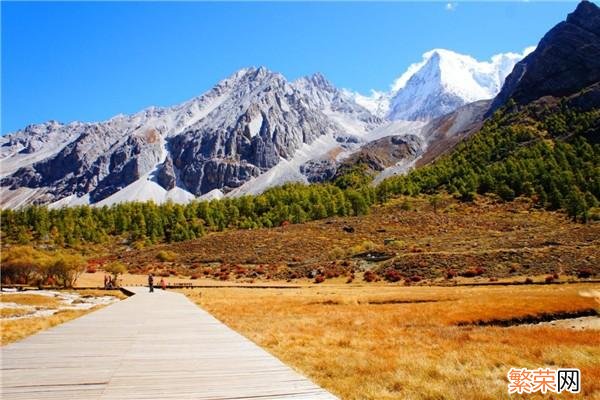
[{"xmin": 1, "ymin": 2, "xmax": 576, "ymax": 134}]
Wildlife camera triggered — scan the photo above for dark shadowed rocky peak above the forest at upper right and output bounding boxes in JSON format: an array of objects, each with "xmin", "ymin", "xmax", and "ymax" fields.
[{"xmin": 490, "ymin": 1, "xmax": 600, "ymax": 113}]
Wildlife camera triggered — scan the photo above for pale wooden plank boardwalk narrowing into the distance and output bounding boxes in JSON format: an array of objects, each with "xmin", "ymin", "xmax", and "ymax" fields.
[{"xmin": 0, "ymin": 288, "xmax": 335, "ymax": 400}]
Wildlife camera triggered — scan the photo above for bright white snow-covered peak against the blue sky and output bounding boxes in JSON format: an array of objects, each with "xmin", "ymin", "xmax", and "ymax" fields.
[{"xmin": 346, "ymin": 48, "xmax": 532, "ymax": 121}]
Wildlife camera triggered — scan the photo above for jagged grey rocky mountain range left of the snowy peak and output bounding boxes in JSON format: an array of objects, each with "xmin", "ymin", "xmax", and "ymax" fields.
[{"xmin": 0, "ymin": 68, "xmax": 383, "ymax": 207}]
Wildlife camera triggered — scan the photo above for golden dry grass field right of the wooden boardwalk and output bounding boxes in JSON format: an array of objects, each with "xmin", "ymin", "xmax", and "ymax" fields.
[{"xmin": 186, "ymin": 285, "xmax": 600, "ymax": 400}]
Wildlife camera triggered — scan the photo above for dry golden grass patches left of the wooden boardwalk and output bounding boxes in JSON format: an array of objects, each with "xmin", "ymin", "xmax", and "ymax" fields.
[{"xmin": 0, "ymin": 290, "xmax": 126, "ymax": 346}]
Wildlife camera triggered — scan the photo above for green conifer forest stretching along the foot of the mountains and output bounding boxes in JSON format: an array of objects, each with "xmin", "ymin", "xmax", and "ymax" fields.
[{"xmin": 1, "ymin": 102, "xmax": 600, "ymax": 246}]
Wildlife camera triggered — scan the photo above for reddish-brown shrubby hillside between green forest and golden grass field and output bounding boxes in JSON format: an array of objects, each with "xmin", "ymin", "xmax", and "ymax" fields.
[{"xmin": 94, "ymin": 197, "xmax": 600, "ymax": 281}]
